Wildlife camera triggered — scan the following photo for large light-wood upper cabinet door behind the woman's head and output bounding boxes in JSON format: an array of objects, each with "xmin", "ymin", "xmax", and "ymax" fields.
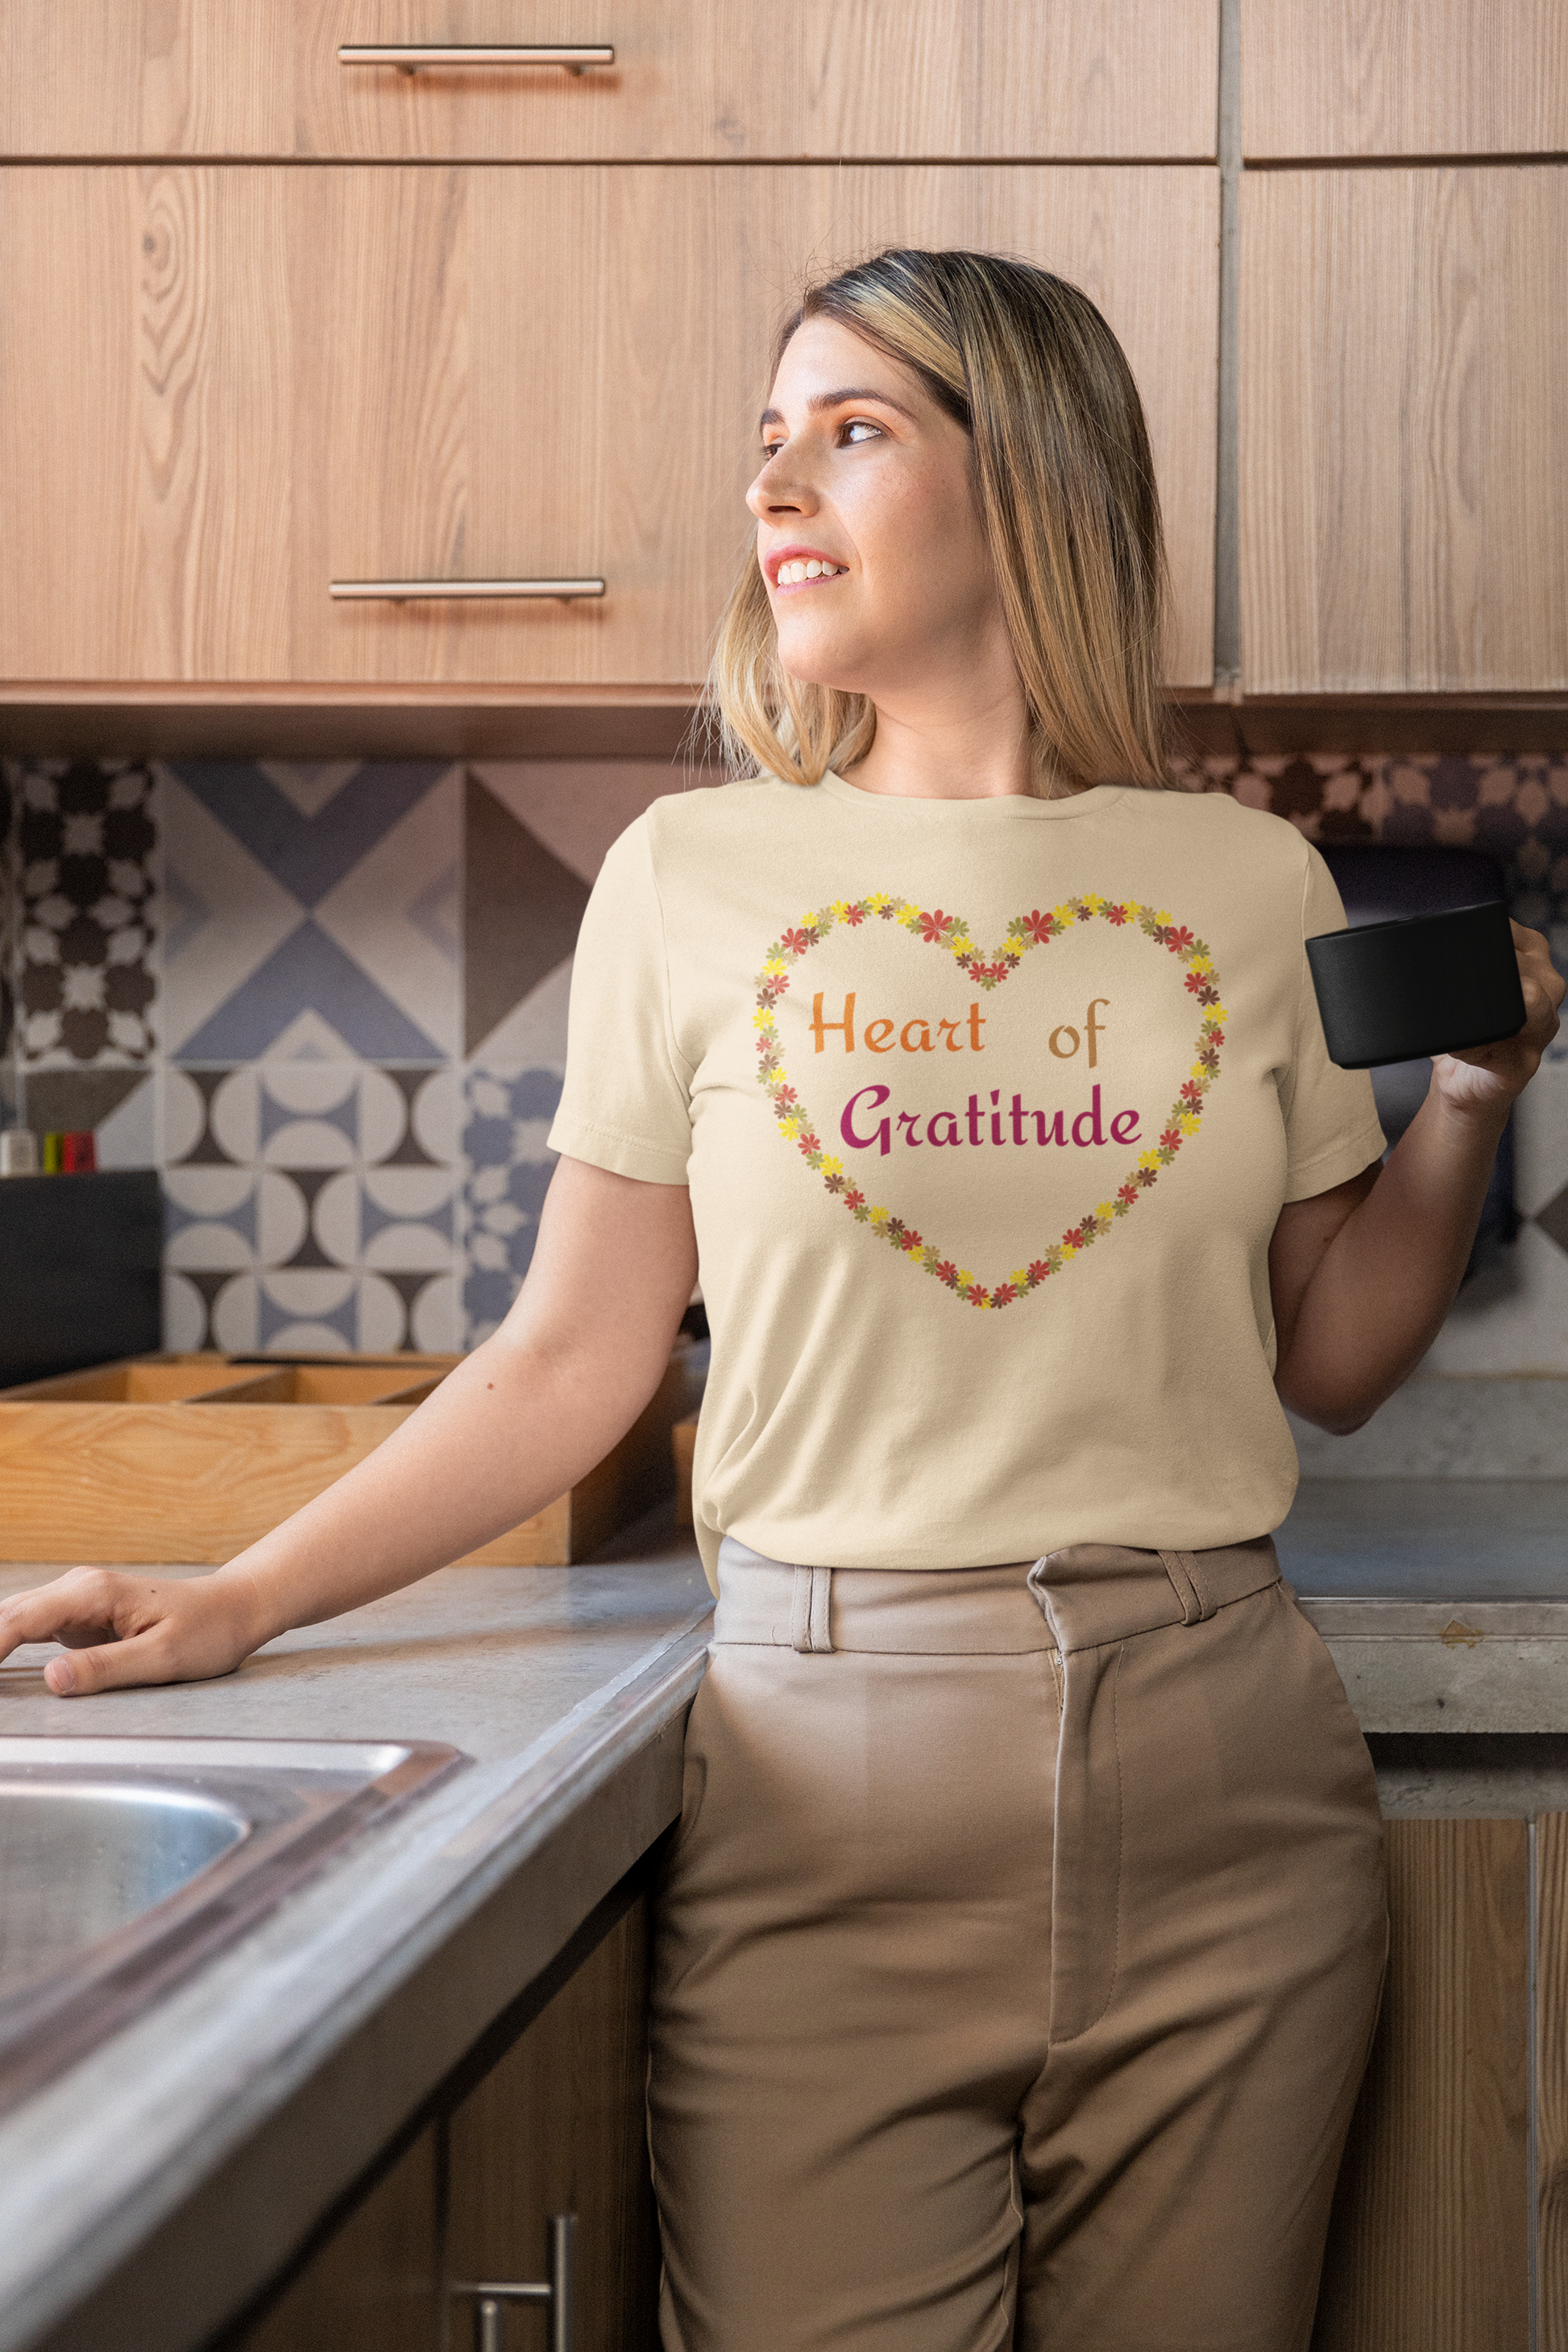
[{"xmin": 0, "ymin": 164, "xmax": 1217, "ymax": 687}]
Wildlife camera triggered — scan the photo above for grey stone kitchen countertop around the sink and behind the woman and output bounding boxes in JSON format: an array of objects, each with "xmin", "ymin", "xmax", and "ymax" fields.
[{"xmin": 0, "ymin": 1475, "xmax": 1568, "ymax": 2352}]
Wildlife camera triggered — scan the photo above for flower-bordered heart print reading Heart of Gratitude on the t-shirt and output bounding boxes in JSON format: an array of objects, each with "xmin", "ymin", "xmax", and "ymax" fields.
[{"xmin": 753, "ymin": 891, "xmax": 1227, "ymax": 1310}]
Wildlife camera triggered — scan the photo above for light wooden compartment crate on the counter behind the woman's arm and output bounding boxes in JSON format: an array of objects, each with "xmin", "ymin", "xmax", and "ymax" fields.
[{"xmin": 0, "ymin": 1341, "xmax": 691, "ymax": 1569}]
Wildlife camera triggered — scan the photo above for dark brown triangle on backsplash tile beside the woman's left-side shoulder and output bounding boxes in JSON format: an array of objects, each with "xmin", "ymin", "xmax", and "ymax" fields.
[{"xmin": 463, "ymin": 776, "xmax": 587, "ymax": 1054}]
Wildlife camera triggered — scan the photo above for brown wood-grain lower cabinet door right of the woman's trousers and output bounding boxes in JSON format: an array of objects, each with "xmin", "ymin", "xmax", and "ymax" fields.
[{"xmin": 1312, "ymin": 1820, "xmax": 1530, "ymax": 2352}]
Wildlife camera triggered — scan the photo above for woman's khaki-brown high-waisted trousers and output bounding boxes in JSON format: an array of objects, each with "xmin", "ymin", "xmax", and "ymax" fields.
[{"xmin": 649, "ymin": 1538, "xmax": 1387, "ymax": 2352}]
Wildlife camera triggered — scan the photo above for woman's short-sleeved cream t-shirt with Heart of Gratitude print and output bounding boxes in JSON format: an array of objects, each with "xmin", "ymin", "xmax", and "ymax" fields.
[{"xmin": 550, "ymin": 776, "xmax": 1383, "ymax": 1576}]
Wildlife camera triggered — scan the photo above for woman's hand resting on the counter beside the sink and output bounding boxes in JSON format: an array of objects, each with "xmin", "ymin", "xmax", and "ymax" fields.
[{"xmin": 0, "ymin": 1566, "xmax": 275, "ymax": 1699}]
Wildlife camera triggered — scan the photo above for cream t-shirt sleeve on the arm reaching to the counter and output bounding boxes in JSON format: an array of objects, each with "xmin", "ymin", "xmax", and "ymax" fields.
[{"xmin": 550, "ymin": 816, "xmax": 691, "ymax": 1183}]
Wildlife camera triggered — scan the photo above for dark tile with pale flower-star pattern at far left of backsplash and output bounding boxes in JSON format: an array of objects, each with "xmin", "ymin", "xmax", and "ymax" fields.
[{"xmin": 16, "ymin": 760, "xmax": 157, "ymax": 1068}]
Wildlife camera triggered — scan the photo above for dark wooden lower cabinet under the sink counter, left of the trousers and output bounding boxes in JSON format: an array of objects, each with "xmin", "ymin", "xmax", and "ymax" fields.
[{"xmin": 223, "ymin": 1894, "xmax": 658, "ymax": 2352}]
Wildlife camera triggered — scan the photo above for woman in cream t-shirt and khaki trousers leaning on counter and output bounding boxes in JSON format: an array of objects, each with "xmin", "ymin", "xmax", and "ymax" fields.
[{"xmin": 0, "ymin": 251, "xmax": 1563, "ymax": 2352}]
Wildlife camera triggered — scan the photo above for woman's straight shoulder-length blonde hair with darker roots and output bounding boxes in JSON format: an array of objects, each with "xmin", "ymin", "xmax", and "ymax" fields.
[{"xmin": 707, "ymin": 249, "xmax": 1168, "ymax": 795}]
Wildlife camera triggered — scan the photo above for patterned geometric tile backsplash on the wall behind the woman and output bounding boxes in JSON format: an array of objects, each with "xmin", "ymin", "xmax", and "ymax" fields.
[{"xmin": 0, "ymin": 753, "xmax": 1568, "ymax": 1374}]
